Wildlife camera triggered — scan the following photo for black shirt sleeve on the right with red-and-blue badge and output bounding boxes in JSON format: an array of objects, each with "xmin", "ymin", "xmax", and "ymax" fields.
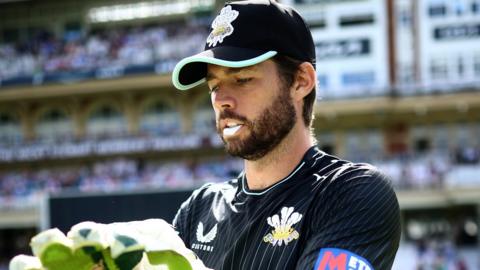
[{"xmin": 296, "ymin": 166, "xmax": 401, "ymax": 270}]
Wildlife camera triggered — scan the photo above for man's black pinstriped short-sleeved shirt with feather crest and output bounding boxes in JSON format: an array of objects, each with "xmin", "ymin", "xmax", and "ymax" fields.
[{"xmin": 173, "ymin": 147, "xmax": 400, "ymax": 270}]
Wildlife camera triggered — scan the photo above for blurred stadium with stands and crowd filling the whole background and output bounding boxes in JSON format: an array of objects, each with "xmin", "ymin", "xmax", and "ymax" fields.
[{"xmin": 0, "ymin": 0, "xmax": 480, "ymax": 270}]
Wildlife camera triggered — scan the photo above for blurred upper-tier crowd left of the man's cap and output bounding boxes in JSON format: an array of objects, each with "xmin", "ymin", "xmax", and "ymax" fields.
[{"xmin": 0, "ymin": 24, "xmax": 208, "ymax": 80}]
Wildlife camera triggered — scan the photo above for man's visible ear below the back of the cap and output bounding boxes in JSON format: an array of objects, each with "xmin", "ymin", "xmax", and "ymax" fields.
[{"xmin": 292, "ymin": 62, "xmax": 317, "ymax": 101}]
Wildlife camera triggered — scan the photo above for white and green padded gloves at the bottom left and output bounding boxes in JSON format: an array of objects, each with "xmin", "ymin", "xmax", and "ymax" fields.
[{"xmin": 9, "ymin": 219, "xmax": 207, "ymax": 270}]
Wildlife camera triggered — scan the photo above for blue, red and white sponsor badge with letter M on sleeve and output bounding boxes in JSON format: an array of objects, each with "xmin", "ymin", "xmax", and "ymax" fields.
[{"xmin": 314, "ymin": 248, "xmax": 373, "ymax": 270}]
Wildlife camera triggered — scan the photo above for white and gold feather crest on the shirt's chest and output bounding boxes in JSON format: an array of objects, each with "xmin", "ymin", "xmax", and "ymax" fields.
[{"xmin": 263, "ymin": 207, "xmax": 302, "ymax": 246}]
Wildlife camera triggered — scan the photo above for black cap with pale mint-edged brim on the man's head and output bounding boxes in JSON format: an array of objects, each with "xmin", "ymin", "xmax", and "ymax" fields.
[{"xmin": 172, "ymin": 0, "xmax": 316, "ymax": 90}]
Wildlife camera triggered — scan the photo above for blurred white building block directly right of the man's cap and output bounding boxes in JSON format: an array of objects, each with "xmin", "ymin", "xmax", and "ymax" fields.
[{"xmin": 297, "ymin": 1, "xmax": 390, "ymax": 99}]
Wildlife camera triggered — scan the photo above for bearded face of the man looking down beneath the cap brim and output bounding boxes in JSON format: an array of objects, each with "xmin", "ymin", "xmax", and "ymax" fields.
[{"xmin": 207, "ymin": 60, "xmax": 296, "ymax": 160}]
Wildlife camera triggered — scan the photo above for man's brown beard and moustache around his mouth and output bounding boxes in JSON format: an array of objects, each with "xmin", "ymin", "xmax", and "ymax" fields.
[{"xmin": 217, "ymin": 86, "xmax": 296, "ymax": 161}]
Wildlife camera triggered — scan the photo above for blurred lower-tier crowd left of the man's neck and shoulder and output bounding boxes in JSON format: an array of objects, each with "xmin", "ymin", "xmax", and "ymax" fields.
[{"xmin": 0, "ymin": 159, "xmax": 242, "ymax": 207}]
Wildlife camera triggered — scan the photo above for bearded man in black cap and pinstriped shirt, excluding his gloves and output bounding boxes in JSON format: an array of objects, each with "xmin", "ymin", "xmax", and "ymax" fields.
[{"xmin": 172, "ymin": 0, "xmax": 400, "ymax": 270}]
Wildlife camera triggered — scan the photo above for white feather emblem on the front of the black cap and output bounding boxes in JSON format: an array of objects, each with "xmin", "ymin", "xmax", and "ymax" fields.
[{"xmin": 207, "ymin": 6, "xmax": 238, "ymax": 47}]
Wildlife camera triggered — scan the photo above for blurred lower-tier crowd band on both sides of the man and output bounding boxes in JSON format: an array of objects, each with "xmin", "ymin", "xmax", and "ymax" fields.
[{"xmin": 0, "ymin": 146, "xmax": 480, "ymax": 207}]
